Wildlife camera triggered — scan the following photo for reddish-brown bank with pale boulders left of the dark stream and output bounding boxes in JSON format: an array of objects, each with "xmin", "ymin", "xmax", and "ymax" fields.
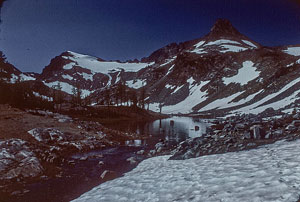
[{"xmin": 0, "ymin": 105, "xmax": 141, "ymax": 201}]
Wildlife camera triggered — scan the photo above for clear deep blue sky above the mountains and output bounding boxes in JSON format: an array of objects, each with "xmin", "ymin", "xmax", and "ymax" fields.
[{"xmin": 0, "ymin": 0, "xmax": 300, "ymax": 72}]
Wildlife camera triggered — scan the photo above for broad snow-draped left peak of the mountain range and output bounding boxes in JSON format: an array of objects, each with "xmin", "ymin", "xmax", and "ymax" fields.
[{"xmin": 40, "ymin": 51, "xmax": 151, "ymax": 96}]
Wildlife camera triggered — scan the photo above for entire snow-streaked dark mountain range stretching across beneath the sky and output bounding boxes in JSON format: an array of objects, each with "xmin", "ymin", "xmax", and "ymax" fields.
[{"xmin": 1, "ymin": 19, "xmax": 300, "ymax": 115}]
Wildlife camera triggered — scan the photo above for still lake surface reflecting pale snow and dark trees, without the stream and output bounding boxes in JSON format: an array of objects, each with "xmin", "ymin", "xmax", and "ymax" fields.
[{"xmin": 103, "ymin": 116, "xmax": 208, "ymax": 146}]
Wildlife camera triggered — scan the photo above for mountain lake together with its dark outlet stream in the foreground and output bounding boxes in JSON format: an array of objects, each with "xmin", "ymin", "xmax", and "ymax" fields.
[{"xmin": 10, "ymin": 116, "xmax": 209, "ymax": 202}]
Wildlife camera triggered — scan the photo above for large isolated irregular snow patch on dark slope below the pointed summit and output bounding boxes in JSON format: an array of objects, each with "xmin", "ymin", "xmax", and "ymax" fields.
[{"xmin": 223, "ymin": 61, "xmax": 259, "ymax": 85}]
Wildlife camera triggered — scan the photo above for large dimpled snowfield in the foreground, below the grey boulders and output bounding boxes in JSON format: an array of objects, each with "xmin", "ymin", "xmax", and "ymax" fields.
[{"xmin": 74, "ymin": 140, "xmax": 300, "ymax": 202}]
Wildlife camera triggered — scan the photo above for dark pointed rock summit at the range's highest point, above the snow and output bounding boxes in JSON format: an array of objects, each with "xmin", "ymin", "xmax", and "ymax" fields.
[{"xmin": 208, "ymin": 19, "xmax": 242, "ymax": 37}]
